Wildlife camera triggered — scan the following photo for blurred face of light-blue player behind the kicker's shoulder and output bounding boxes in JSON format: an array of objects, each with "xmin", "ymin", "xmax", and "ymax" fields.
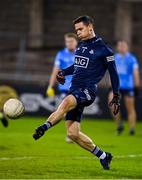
[{"xmin": 65, "ymin": 37, "xmax": 77, "ymax": 51}]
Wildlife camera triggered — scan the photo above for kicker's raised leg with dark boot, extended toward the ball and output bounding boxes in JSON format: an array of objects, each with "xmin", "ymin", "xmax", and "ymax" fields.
[{"xmin": 33, "ymin": 95, "xmax": 77, "ymax": 140}]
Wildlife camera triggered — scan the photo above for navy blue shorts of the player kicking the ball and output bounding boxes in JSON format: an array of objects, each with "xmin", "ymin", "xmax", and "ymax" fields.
[{"xmin": 66, "ymin": 88, "xmax": 97, "ymax": 122}]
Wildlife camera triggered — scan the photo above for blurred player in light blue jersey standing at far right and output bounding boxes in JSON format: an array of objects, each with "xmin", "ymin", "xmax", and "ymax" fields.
[{"xmin": 109, "ymin": 40, "xmax": 140, "ymax": 135}]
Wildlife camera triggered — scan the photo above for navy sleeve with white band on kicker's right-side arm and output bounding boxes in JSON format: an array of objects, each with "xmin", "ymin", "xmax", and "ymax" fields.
[{"xmin": 104, "ymin": 48, "xmax": 119, "ymax": 94}]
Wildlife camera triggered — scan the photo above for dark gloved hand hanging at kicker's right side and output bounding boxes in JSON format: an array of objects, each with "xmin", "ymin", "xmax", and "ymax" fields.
[{"xmin": 109, "ymin": 93, "xmax": 120, "ymax": 116}]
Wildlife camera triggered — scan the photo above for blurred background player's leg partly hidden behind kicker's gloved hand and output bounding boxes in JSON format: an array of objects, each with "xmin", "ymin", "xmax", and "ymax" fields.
[{"xmin": 108, "ymin": 91, "xmax": 124, "ymax": 134}]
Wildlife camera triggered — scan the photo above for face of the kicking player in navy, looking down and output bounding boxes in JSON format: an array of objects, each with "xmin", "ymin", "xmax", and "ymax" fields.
[{"xmin": 75, "ymin": 22, "xmax": 93, "ymax": 40}]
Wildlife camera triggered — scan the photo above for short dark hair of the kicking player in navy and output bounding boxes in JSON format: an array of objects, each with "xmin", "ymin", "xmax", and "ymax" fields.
[{"xmin": 73, "ymin": 15, "xmax": 94, "ymax": 26}]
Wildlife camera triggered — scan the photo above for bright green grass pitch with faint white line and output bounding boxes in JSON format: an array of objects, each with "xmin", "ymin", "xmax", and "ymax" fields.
[{"xmin": 0, "ymin": 117, "xmax": 142, "ymax": 179}]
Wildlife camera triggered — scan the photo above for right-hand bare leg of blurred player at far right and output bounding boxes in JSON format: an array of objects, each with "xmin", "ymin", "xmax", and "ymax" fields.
[{"xmin": 124, "ymin": 96, "xmax": 136, "ymax": 135}]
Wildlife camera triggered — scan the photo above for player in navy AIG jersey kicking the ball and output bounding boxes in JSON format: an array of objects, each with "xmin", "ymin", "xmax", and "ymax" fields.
[{"xmin": 33, "ymin": 16, "xmax": 120, "ymax": 170}]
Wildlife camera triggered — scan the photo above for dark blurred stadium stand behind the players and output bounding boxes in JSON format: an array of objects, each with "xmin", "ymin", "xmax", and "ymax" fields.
[{"xmin": 0, "ymin": 0, "xmax": 142, "ymax": 119}]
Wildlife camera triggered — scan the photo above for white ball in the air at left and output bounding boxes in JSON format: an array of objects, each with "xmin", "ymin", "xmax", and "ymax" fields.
[{"xmin": 3, "ymin": 99, "xmax": 25, "ymax": 119}]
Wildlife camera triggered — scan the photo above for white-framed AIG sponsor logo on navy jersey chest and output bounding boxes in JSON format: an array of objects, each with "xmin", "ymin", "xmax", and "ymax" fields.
[{"xmin": 74, "ymin": 55, "xmax": 89, "ymax": 68}]
